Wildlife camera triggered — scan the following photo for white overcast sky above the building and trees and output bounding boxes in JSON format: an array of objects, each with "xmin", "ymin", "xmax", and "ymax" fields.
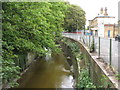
[{"xmin": 66, "ymin": 0, "xmax": 120, "ymax": 25}]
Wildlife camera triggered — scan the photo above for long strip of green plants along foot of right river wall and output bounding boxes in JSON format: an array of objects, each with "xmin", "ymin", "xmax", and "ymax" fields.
[{"xmin": 64, "ymin": 38, "xmax": 96, "ymax": 89}]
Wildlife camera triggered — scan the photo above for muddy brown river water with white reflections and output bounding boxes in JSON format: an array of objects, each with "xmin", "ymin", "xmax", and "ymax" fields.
[{"xmin": 24, "ymin": 54, "xmax": 73, "ymax": 88}]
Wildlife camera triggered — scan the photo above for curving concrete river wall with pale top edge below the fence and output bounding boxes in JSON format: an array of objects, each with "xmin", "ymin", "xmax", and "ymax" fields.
[{"xmin": 65, "ymin": 37, "xmax": 118, "ymax": 88}]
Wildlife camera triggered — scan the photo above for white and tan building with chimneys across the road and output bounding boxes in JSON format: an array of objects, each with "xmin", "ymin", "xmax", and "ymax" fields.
[{"xmin": 89, "ymin": 8, "xmax": 118, "ymax": 37}]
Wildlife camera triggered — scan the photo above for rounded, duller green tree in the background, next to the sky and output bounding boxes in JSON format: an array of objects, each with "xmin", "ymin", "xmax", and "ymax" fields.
[{"xmin": 64, "ymin": 5, "xmax": 86, "ymax": 32}]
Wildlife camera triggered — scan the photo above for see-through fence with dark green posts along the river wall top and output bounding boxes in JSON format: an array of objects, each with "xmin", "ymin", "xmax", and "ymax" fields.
[{"xmin": 63, "ymin": 33, "xmax": 120, "ymax": 71}]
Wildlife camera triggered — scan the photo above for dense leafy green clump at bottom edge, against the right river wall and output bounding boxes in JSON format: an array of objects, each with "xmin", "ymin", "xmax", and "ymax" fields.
[{"xmin": 77, "ymin": 69, "xmax": 96, "ymax": 88}]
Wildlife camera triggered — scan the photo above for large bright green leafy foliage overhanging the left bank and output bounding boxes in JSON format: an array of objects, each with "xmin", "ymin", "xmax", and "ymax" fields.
[{"xmin": 2, "ymin": 2, "xmax": 68, "ymax": 87}]
